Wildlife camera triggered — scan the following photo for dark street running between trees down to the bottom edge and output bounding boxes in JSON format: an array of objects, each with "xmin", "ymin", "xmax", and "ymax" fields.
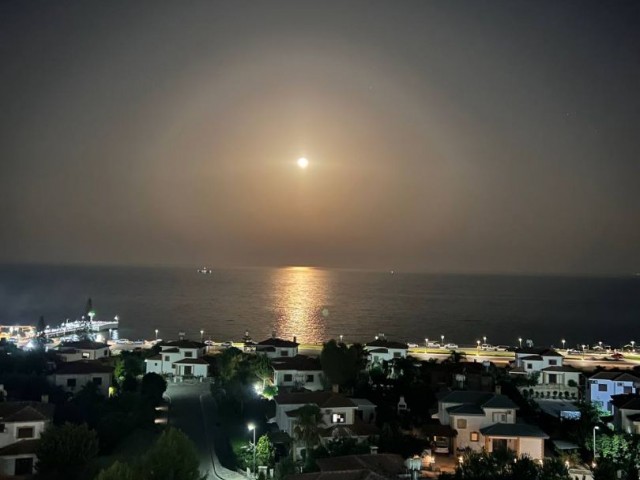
[{"xmin": 164, "ymin": 382, "xmax": 247, "ymax": 480}]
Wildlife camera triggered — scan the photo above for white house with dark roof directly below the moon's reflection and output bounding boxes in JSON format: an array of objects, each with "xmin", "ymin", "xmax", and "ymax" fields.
[{"xmin": 272, "ymin": 355, "xmax": 324, "ymax": 391}]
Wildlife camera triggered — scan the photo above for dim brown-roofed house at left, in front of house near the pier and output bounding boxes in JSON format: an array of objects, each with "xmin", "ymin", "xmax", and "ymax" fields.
[{"xmin": 48, "ymin": 360, "xmax": 113, "ymax": 396}]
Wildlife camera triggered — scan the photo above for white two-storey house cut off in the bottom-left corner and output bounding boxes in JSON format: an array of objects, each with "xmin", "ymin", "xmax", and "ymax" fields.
[{"xmin": 0, "ymin": 402, "xmax": 54, "ymax": 478}]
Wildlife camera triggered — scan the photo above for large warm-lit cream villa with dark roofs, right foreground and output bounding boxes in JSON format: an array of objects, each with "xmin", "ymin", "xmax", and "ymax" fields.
[{"xmin": 434, "ymin": 390, "xmax": 549, "ymax": 460}]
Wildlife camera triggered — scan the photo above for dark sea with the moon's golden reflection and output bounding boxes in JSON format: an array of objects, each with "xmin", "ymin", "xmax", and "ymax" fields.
[{"xmin": 0, "ymin": 265, "xmax": 640, "ymax": 347}]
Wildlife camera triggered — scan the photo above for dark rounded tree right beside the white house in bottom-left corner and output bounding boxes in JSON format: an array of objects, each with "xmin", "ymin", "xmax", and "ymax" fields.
[{"xmin": 36, "ymin": 423, "xmax": 98, "ymax": 478}]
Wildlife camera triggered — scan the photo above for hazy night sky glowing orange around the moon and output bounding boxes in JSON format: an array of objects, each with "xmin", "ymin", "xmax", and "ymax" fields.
[{"xmin": 0, "ymin": 0, "xmax": 640, "ymax": 274}]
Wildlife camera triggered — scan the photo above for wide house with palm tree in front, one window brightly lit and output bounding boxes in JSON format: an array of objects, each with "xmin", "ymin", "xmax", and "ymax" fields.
[{"xmin": 275, "ymin": 391, "xmax": 378, "ymax": 453}]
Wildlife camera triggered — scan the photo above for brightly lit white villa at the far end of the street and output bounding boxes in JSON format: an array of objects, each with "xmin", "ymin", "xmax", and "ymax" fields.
[{"xmin": 145, "ymin": 339, "xmax": 209, "ymax": 378}]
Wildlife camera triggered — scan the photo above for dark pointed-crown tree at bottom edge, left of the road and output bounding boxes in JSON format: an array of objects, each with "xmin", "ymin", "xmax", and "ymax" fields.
[{"xmin": 141, "ymin": 428, "xmax": 206, "ymax": 480}]
